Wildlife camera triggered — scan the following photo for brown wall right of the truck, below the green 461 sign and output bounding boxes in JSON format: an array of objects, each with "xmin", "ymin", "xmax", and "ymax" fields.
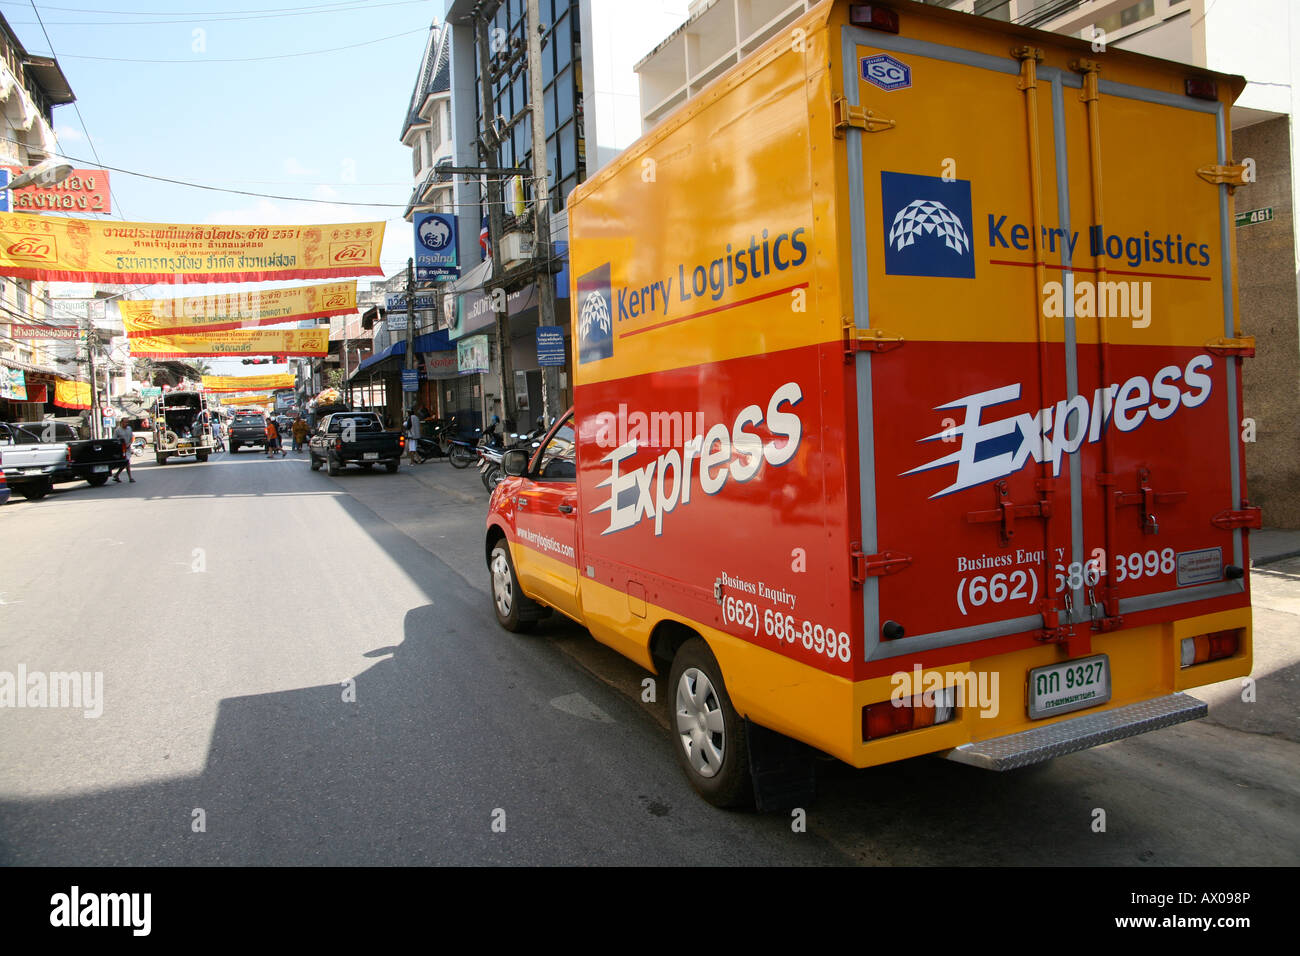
[{"xmin": 1232, "ymin": 116, "xmax": 1300, "ymax": 528}]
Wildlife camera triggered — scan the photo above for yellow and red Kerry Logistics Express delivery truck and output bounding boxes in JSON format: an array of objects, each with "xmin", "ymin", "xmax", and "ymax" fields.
[{"xmin": 485, "ymin": 1, "xmax": 1260, "ymax": 805}]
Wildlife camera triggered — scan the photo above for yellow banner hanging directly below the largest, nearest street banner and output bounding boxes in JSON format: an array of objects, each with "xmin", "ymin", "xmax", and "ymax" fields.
[{"xmin": 117, "ymin": 280, "xmax": 356, "ymax": 338}]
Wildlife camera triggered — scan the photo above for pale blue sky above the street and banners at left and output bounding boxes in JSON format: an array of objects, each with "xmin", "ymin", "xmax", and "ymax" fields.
[{"xmin": 0, "ymin": 0, "xmax": 443, "ymax": 382}]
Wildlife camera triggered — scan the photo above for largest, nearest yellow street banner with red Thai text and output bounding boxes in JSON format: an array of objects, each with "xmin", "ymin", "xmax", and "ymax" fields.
[{"xmin": 0, "ymin": 213, "xmax": 384, "ymax": 282}]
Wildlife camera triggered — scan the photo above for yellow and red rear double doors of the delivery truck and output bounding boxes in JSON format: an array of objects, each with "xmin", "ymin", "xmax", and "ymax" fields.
[{"xmin": 841, "ymin": 16, "xmax": 1244, "ymax": 659}]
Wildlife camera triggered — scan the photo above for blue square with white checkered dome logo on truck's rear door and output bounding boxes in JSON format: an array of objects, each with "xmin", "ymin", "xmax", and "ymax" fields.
[{"xmin": 880, "ymin": 170, "xmax": 975, "ymax": 278}]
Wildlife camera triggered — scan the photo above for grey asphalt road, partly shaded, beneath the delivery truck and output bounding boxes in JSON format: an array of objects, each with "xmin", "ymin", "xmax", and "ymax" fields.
[{"xmin": 0, "ymin": 451, "xmax": 1300, "ymax": 865}]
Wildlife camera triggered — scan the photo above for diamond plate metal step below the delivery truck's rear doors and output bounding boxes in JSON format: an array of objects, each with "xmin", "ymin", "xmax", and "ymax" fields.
[{"xmin": 943, "ymin": 693, "xmax": 1209, "ymax": 770}]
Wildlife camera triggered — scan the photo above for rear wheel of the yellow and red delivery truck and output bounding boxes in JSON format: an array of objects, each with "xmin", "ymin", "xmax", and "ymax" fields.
[{"xmin": 668, "ymin": 637, "xmax": 754, "ymax": 808}]
